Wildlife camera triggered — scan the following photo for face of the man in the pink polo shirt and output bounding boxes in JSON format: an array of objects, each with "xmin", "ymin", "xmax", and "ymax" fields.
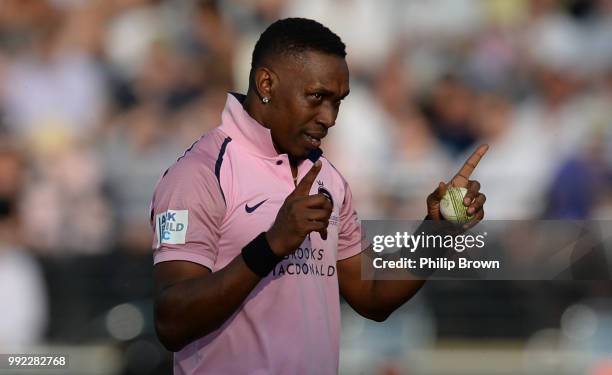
[{"xmin": 266, "ymin": 51, "xmax": 349, "ymax": 161}]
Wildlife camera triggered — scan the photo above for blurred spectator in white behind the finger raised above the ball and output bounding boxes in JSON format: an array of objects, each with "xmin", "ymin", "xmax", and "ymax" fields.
[{"xmin": 460, "ymin": 94, "xmax": 553, "ymax": 220}]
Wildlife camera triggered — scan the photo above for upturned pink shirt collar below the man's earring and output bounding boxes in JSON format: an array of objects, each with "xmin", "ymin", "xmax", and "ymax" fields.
[{"xmin": 221, "ymin": 93, "xmax": 279, "ymax": 158}]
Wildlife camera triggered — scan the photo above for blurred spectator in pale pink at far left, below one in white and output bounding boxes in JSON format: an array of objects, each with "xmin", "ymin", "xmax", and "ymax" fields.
[{"xmin": 22, "ymin": 142, "xmax": 113, "ymax": 255}]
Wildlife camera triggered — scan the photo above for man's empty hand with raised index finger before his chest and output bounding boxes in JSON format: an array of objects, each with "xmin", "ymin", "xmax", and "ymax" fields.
[{"xmin": 266, "ymin": 160, "xmax": 333, "ymax": 256}]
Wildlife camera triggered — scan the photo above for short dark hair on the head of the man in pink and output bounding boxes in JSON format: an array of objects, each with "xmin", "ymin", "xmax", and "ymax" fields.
[{"xmin": 251, "ymin": 18, "xmax": 346, "ymax": 75}]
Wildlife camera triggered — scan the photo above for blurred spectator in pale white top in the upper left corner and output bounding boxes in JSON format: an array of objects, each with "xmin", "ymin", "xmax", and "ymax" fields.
[{"xmin": 0, "ymin": 1, "xmax": 106, "ymax": 142}]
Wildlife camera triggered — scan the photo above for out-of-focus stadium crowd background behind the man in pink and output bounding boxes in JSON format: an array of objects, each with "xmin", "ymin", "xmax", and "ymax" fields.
[{"xmin": 0, "ymin": 0, "xmax": 612, "ymax": 375}]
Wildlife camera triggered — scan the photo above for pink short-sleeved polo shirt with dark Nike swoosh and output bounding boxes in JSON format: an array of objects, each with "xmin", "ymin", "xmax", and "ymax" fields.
[{"xmin": 151, "ymin": 94, "xmax": 361, "ymax": 374}]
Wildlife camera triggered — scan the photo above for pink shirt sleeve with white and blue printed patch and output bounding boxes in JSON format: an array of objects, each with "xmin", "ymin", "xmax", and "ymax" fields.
[{"xmin": 151, "ymin": 159, "xmax": 225, "ymax": 270}]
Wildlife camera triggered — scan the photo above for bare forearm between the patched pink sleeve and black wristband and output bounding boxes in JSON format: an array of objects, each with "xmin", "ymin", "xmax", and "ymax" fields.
[{"xmin": 155, "ymin": 255, "xmax": 261, "ymax": 351}]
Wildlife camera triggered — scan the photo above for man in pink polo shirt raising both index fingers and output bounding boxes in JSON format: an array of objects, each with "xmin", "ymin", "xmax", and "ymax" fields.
[{"xmin": 151, "ymin": 18, "xmax": 486, "ymax": 374}]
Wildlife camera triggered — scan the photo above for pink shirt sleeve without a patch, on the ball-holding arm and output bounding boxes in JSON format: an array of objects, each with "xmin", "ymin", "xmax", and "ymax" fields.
[{"xmin": 338, "ymin": 182, "xmax": 362, "ymax": 260}]
